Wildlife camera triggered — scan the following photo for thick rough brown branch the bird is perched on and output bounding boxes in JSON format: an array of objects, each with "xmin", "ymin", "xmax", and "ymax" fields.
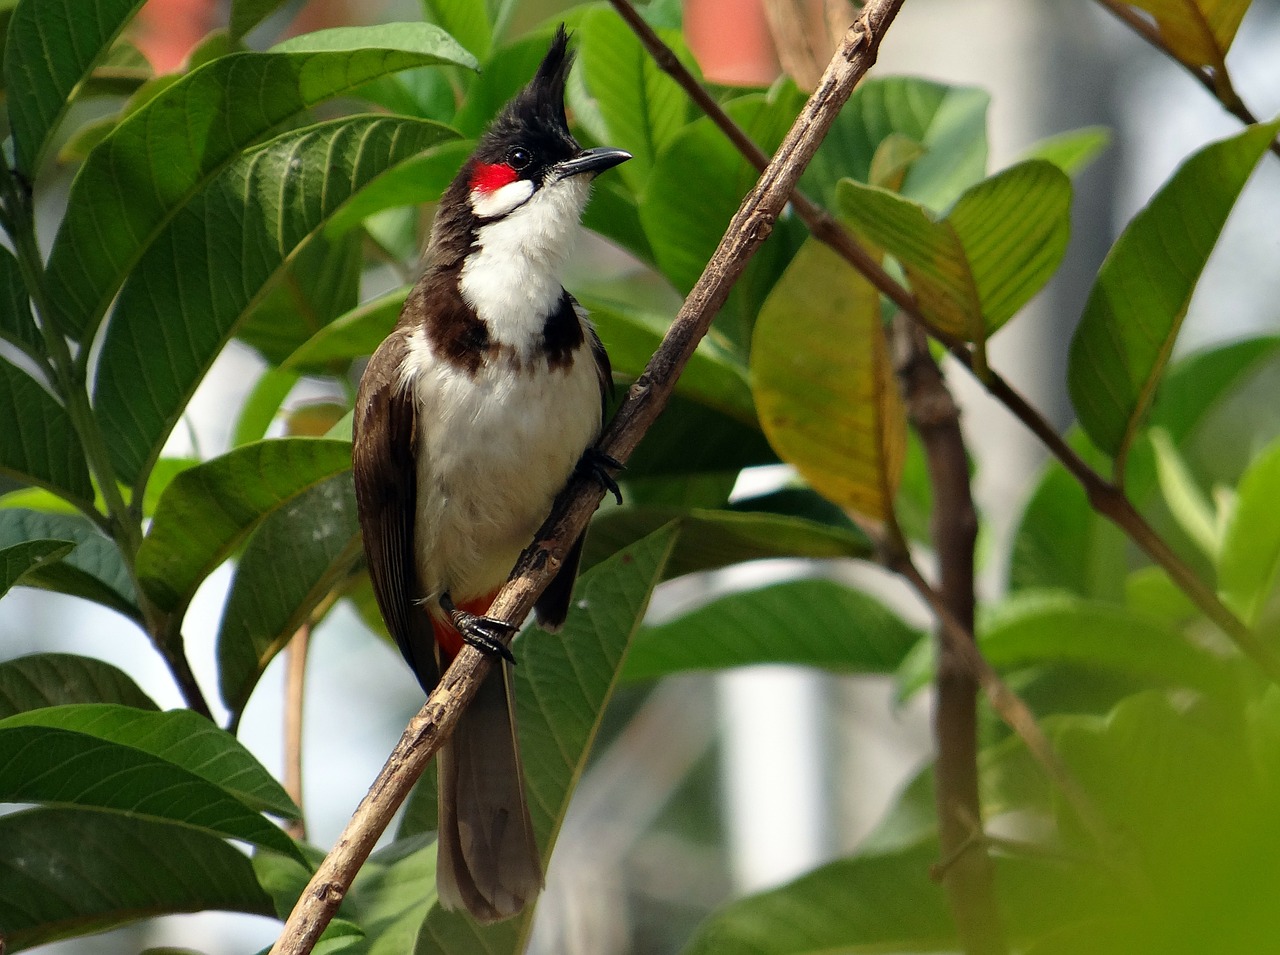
[{"xmin": 271, "ymin": 0, "xmax": 904, "ymax": 955}]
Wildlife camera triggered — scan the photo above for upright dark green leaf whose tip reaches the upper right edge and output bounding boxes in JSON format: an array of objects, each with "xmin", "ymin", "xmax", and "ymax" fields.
[{"xmin": 1068, "ymin": 120, "xmax": 1280, "ymax": 478}]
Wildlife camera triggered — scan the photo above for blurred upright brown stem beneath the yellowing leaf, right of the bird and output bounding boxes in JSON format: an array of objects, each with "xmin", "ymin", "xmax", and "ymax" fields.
[{"xmin": 893, "ymin": 320, "xmax": 1007, "ymax": 955}]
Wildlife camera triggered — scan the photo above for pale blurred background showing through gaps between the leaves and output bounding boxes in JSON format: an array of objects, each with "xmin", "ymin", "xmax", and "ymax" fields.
[{"xmin": 10, "ymin": 0, "xmax": 1280, "ymax": 955}]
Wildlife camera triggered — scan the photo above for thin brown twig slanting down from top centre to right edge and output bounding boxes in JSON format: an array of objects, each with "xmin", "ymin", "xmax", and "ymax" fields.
[{"xmin": 609, "ymin": 0, "xmax": 1280, "ymax": 684}]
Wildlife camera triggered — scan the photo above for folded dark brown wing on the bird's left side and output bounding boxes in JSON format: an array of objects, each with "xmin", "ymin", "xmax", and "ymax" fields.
[{"xmin": 351, "ymin": 329, "xmax": 440, "ymax": 693}]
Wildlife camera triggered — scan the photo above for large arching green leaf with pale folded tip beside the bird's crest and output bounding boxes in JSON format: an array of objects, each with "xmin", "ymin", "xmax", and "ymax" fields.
[{"xmin": 47, "ymin": 35, "xmax": 474, "ymax": 335}]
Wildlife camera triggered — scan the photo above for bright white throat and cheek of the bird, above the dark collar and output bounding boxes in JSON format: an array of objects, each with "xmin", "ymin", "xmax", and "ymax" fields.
[{"xmin": 460, "ymin": 175, "xmax": 591, "ymax": 357}]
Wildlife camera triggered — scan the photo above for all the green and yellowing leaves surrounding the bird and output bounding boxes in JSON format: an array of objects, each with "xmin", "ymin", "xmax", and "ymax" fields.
[{"xmin": 0, "ymin": 0, "xmax": 1280, "ymax": 955}]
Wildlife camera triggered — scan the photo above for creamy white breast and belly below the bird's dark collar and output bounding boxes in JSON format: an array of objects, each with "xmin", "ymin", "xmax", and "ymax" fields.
[{"xmin": 406, "ymin": 321, "xmax": 600, "ymax": 602}]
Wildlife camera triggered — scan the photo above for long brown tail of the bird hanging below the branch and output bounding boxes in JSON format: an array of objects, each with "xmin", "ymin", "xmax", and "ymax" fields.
[{"xmin": 433, "ymin": 595, "xmax": 543, "ymax": 922}]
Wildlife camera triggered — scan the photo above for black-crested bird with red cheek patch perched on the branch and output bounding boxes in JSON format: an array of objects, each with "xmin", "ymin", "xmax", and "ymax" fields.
[{"xmin": 352, "ymin": 24, "xmax": 631, "ymax": 923}]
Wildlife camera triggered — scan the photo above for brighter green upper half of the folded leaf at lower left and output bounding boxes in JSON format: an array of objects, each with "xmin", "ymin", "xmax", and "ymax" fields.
[{"xmin": 0, "ymin": 703, "xmax": 298, "ymax": 819}]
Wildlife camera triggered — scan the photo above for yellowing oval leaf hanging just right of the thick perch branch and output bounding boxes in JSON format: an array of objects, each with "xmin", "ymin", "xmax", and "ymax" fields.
[{"xmin": 751, "ymin": 239, "xmax": 906, "ymax": 522}]
